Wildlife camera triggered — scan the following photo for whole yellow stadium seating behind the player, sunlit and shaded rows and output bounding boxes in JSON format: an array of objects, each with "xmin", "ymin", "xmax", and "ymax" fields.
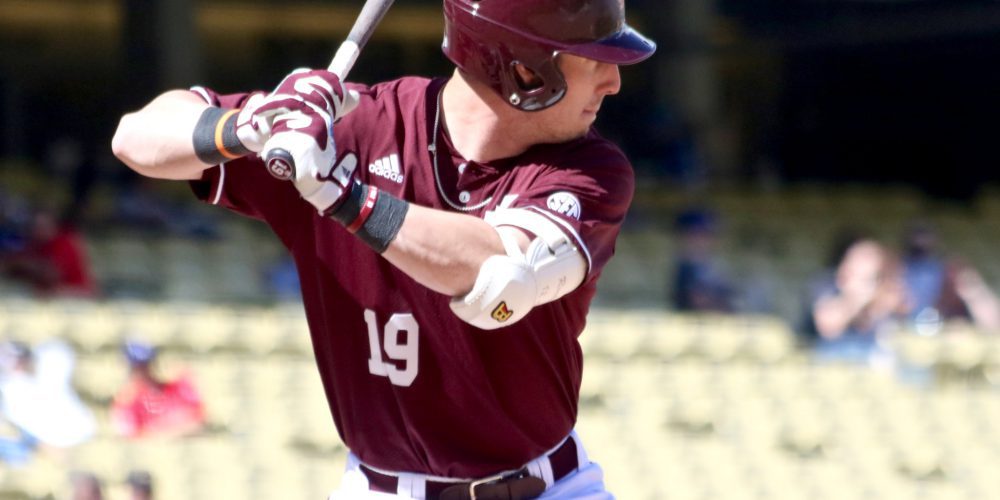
[{"xmin": 0, "ymin": 186, "xmax": 1000, "ymax": 500}]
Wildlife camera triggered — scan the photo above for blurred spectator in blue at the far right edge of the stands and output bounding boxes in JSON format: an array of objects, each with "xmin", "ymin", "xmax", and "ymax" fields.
[{"xmin": 903, "ymin": 222, "xmax": 1000, "ymax": 333}]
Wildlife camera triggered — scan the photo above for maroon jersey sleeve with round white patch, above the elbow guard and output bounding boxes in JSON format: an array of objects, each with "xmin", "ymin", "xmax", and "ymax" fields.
[{"xmin": 510, "ymin": 144, "xmax": 635, "ymax": 281}]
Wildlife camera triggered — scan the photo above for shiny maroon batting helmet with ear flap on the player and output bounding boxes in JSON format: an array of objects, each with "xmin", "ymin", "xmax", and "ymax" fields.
[{"xmin": 442, "ymin": 0, "xmax": 656, "ymax": 111}]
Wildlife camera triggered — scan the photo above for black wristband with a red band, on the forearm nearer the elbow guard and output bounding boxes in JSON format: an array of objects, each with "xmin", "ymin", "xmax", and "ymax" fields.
[{"xmin": 328, "ymin": 182, "xmax": 410, "ymax": 254}]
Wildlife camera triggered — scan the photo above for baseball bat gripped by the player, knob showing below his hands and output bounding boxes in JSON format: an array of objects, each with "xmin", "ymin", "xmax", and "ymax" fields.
[{"xmin": 264, "ymin": 0, "xmax": 395, "ymax": 177}]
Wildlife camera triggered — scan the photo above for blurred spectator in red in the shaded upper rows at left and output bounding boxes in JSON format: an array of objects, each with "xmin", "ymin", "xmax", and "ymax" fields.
[{"xmin": 0, "ymin": 210, "xmax": 97, "ymax": 297}]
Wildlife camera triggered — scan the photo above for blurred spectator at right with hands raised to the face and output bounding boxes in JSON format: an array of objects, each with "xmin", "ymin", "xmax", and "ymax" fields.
[{"xmin": 810, "ymin": 236, "xmax": 910, "ymax": 361}]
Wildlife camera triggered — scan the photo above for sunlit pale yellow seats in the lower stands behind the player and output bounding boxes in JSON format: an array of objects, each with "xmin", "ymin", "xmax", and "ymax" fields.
[{"xmin": 0, "ymin": 300, "xmax": 1000, "ymax": 499}]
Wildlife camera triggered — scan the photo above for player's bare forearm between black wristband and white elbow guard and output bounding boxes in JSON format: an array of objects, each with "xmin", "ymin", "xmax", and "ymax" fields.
[{"xmin": 382, "ymin": 205, "xmax": 504, "ymax": 297}]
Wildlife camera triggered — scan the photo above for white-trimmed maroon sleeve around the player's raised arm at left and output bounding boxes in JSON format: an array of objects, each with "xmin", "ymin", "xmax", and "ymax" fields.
[{"xmin": 190, "ymin": 87, "xmax": 315, "ymax": 246}]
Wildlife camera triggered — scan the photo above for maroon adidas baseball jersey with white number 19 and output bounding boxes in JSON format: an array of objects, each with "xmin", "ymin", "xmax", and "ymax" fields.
[{"xmin": 192, "ymin": 78, "xmax": 634, "ymax": 478}]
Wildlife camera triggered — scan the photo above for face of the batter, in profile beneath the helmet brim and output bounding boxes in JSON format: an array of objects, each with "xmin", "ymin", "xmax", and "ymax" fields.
[{"xmin": 539, "ymin": 54, "xmax": 621, "ymax": 142}]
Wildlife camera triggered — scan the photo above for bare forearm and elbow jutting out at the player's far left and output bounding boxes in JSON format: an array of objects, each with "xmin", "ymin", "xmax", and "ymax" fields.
[{"xmin": 111, "ymin": 90, "xmax": 210, "ymax": 180}]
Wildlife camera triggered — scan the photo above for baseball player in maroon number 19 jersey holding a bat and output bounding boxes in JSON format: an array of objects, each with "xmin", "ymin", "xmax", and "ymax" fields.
[{"xmin": 113, "ymin": 0, "xmax": 655, "ymax": 500}]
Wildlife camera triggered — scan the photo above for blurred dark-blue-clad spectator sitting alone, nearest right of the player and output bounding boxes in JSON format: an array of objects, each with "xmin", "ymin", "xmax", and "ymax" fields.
[{"xmin": 672, "ymin": 209, "xmax": 735, "ymax": 312}]
